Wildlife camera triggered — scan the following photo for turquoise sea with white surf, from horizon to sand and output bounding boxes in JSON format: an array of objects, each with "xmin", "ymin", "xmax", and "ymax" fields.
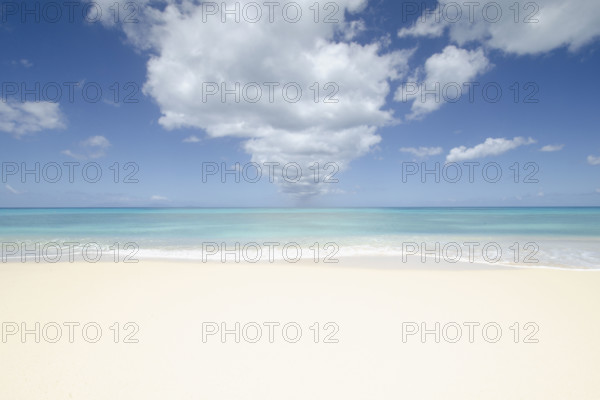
[{"xmin": 0, "ymin": 208, "xmax": 600, "ymax": 269}]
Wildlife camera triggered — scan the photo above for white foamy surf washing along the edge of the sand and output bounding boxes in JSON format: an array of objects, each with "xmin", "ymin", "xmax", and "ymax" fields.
[{"xmin": 0, "ymin": 236, "xmax": 600, "ymax": 271}]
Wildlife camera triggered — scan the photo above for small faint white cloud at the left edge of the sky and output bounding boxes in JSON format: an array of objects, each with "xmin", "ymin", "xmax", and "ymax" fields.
[{"xmin": 0, "ymin": 102, "xmax": 66, "ymax": 138}]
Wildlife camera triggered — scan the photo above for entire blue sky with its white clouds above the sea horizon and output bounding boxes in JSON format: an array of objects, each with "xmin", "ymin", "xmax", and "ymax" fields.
[{"xmin": 0, "ymin": 0, "xmax": 600, "ymax": 207}]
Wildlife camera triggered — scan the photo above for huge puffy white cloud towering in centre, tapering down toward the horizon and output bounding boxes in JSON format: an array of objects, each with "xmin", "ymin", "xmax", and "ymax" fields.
[{"xmin": 94, "ymin": 0, "xmax": 412, "ymax": 196}]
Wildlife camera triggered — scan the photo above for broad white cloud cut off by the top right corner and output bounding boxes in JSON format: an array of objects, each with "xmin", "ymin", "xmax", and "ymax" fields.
[{"xmin": 398, "ymin": 0, "xmax": 600, "ymax": 55}]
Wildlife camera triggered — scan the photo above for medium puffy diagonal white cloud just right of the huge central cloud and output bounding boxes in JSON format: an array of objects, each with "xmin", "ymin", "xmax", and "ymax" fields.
[{"xmin": 394, "ymin": 46, "xmax": 490, "ymax": 119}]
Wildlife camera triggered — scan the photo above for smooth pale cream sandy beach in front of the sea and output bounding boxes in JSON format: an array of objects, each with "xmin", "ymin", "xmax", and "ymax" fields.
[{"xmin": 0, "ymin": 259, "xmax": 600, "ymax": 399}]
